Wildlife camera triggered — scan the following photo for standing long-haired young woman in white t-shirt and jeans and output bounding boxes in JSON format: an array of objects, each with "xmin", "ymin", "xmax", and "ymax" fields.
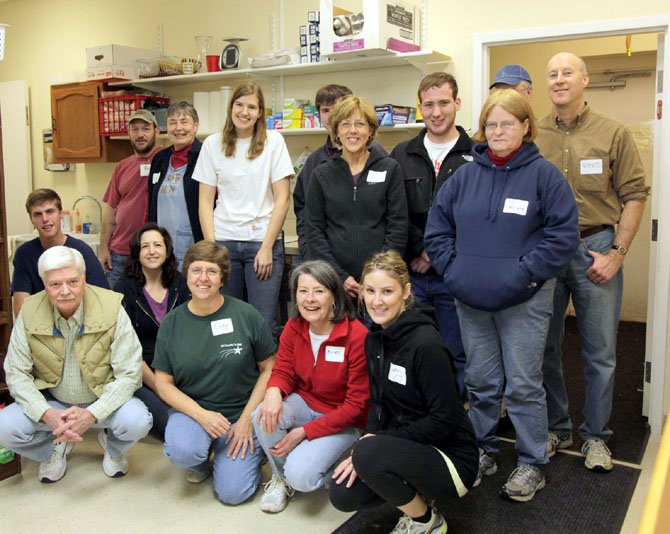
[{"xmin": 193, "ymin": 80, "xmax": 293, "ymax": 328}]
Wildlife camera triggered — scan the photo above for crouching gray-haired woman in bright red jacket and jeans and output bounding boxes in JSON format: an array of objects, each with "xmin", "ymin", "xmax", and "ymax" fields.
[{"xmin": 253, "ymin": 261, "xmax": 370, "ymax": 512}]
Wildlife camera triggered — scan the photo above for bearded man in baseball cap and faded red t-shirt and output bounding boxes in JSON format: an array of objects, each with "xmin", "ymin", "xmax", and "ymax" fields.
[{"xmin": 98, "ymin": 109, "xmax": 159, "ymax": 288}]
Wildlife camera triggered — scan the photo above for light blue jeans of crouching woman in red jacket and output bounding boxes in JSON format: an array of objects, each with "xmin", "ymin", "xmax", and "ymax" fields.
[{"xmin": 253, "ymin": 393, "xmax": 361, "ymax": 493}]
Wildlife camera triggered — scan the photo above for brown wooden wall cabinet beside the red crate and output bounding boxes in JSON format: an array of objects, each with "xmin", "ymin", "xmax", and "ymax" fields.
[{"xmin": 51, "ymin": 82, "xmax": 132, "ymax": 163}]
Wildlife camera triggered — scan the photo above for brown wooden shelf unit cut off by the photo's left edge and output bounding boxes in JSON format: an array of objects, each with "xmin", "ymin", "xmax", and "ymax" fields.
[{"xmin": 0, "ymin": 105, "xmax": 21, "ymax": 480}]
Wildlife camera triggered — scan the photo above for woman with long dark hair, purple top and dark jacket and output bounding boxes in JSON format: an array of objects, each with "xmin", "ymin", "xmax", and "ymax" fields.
[{"xmin": 114, "ymin": 223, "xmax": 191, "ymax": 441}]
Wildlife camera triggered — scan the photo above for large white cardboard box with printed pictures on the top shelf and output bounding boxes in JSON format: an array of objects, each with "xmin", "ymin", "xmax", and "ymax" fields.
[{"xmin": 320, "ymin": 0, "xmax": 421, "ymax": 58}]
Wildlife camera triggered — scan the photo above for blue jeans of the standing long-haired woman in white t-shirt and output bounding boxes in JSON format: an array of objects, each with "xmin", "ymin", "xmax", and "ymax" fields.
[{"xmin": 217, "ymin": 240, "xmax": 284, "ymax": 332}]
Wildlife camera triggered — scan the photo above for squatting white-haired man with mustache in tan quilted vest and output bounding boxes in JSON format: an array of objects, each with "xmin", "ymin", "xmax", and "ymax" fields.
[{"xmin": 0, "ymin": 246, "xmax": 152, "ymax": 482}]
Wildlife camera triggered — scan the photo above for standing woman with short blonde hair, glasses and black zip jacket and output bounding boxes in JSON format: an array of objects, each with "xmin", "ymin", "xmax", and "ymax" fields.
[{"xmin": 305, "ymin": 96, "xmax": 409, "ymax": 298}]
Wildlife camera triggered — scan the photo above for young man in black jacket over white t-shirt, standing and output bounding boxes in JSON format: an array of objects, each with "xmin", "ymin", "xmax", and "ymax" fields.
[{"xmin": 391, "ymin": 72, "xmax": 472, "ymax": 395}]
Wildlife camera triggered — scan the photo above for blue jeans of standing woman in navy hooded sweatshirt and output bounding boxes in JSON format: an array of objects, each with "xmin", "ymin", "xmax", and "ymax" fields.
[{"xmin": 456, "ymin": 279, "xmax": 556, "ymax": 465}]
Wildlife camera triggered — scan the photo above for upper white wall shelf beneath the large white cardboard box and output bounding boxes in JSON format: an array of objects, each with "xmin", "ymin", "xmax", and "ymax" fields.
[{"xmin": 109, "ymin": 51, "xmax": 451, "ymax": 90}]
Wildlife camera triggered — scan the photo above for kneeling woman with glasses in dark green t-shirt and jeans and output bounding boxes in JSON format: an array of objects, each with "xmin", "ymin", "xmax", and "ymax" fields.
[{"xmin": 153, "ymin": 241, "xmax": 276, "ymax": 504}]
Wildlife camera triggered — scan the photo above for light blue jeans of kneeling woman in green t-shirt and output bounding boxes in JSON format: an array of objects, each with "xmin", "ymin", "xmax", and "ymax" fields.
[{"xmin": 164, "ymin": 408, "xmax": 263, "ymax": 505}]
